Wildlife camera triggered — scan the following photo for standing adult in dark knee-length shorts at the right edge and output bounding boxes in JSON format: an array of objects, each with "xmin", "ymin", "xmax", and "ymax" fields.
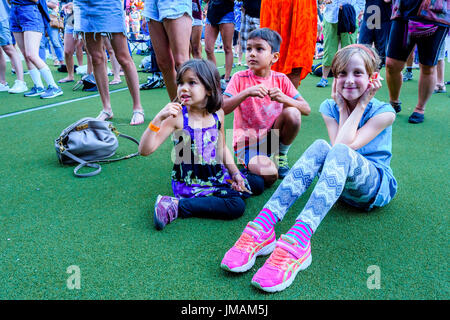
[{"xmin": 386, "ymin": 0, "xmax": 450, "ymax": 123}]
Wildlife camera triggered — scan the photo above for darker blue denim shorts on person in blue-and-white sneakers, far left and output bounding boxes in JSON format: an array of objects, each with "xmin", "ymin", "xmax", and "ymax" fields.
[{"xmin": 9, "ymin": 4, "xmax": 45, "ymax": 33}]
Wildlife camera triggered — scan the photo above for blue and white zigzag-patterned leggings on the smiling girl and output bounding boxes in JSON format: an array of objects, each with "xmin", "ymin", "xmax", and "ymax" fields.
[{"xmin": 264, "ymin": 140, "xmax": 381, "ymax": 231}]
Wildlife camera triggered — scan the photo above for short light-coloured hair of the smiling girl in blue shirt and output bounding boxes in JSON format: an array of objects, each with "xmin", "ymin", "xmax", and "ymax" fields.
[{"xmin": 331, "ymin": 44, "xmax": 381, "ymax": 77}]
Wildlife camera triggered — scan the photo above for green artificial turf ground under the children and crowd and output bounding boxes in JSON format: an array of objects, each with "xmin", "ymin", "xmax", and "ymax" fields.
[{"xmin": 0, "ymin": 52, "xmax": 450, "ymax": 300}]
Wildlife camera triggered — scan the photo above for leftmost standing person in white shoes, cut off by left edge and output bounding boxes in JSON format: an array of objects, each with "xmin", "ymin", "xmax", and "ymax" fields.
[{"xmin": 0, "ymin": 0, "xmax": 28, "ymax": 93}]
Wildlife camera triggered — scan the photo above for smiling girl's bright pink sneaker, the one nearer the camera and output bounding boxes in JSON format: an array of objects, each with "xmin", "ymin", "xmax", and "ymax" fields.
[{"xmin": 252, "ymin": 234, "xmax": 312, "ymax": 292}]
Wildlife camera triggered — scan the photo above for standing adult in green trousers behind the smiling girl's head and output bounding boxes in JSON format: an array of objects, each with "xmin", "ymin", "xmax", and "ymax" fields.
[{"xmin": 316, "ymin": 0, "xmax": 365, "ymax": 88}]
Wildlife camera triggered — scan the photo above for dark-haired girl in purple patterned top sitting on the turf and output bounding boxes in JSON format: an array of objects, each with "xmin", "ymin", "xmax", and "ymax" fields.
[{"xmin": 139, "ymin": 59, "xmax": 264, "ymax": 230}]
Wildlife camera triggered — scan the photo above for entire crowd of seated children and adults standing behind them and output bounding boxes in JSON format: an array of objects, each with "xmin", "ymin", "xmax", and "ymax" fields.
[{"xmin": 0, "ymin": 0, "xmax": 450, "ymax": 292}]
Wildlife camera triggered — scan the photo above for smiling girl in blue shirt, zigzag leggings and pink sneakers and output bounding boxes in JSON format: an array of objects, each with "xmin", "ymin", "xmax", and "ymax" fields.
[{"xmin": 221, "ymin": 44, "xmax": 397, "ymax": 292}]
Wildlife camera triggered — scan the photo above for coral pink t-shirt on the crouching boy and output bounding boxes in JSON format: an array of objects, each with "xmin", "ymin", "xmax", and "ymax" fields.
[{"xmin": 224, "ymin": 69, "xmax": 300, "ymax": 149}]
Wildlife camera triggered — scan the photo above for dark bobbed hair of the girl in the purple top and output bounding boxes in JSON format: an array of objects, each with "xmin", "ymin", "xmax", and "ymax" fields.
[{"xmin": 177, "ymin": 59, "xmax": 223, "ymax": 113}]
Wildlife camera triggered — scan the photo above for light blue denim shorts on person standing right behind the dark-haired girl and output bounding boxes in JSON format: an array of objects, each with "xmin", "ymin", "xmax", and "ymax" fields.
[{"xmin": 143, "ymin": 0, "xmax": 192, "ymax": 22}]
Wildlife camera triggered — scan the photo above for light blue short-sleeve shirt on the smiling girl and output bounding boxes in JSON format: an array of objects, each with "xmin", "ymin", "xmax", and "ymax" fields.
[{"xmin": 319, "ymin": 98, "xmax": 397, "ymax": 210}]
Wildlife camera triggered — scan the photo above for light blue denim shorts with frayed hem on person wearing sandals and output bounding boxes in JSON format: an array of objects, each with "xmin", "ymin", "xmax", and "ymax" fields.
[{"xmin": 73, "ymin": 0, "xmax": 126, "ymax": 34}]
